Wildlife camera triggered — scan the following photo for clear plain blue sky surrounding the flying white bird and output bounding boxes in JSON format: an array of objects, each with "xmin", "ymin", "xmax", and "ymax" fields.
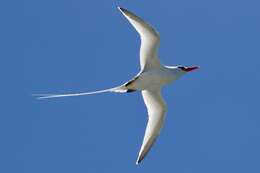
[{"xmin": 0, "ymin": 0, "xmax": 260, "ymax": 173}]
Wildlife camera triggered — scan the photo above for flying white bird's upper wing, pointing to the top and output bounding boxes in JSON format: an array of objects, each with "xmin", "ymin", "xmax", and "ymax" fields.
[{"xmin": 118, "ymin": 7, "xmax": 161, "ymax": 71}]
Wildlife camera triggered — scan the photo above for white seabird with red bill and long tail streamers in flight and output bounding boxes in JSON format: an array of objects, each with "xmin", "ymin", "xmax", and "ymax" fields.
[{"xmin": 36, "ymin": 7, "xmax": 198, "ymax": 165}]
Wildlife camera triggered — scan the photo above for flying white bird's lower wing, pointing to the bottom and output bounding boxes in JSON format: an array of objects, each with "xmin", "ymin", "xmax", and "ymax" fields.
[{"xmin": 136, "ymin": 89, "xmax": 167, "ymax": 164}]
